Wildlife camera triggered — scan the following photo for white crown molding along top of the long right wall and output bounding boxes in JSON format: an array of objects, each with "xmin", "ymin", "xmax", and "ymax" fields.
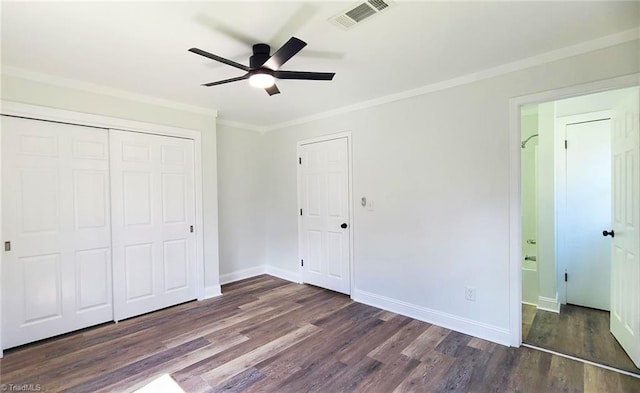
[{"xmin": 256, "ymin": 27, "xmax": 640, "ymax": 132}]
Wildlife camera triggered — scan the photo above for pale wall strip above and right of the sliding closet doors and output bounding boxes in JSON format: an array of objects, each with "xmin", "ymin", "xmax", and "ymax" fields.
[{"xmin": 1, "ymin": 75, "xmax": 219, "ymax": 295}]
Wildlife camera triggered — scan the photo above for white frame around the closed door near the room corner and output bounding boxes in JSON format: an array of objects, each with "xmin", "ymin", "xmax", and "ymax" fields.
[{"xmin": 295, "ymin": 131, "xmax": 355, "ymax": 298}]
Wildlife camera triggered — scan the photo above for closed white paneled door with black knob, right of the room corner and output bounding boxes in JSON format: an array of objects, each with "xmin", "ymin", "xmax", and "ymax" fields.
[{"xmin": 298, "ymin": 137, "xmax": 351, "ymax": 294}]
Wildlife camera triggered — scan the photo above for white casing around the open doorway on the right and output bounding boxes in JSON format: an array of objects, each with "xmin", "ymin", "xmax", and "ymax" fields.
[{"xmin": 509, "ymin": 73, "xmax": 640, "ymax": 347}]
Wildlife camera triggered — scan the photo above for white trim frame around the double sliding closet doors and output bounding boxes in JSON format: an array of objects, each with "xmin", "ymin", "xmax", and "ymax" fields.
[{"xmin": 0, "ymin": 100, "xmax": 206, "ymax": 358}]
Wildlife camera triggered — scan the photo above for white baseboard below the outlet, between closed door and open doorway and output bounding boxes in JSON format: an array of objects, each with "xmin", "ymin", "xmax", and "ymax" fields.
[{"xmin": 352, "ymin": 289, "xmax": 511, "ymax": 346}]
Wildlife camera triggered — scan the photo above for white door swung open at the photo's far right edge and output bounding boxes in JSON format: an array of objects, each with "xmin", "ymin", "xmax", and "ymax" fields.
[{"xmin": 611, "ymin": 88, "xmax": 640, "ymax": 367}]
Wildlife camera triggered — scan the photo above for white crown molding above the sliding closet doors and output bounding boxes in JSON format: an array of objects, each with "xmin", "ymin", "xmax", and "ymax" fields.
[{"xmin": 2, "ymin": 65, "xmax": 218, "ymax": 117}]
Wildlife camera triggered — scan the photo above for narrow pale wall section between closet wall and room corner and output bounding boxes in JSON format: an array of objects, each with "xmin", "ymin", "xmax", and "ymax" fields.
[{"xmin": 217, "ymin": 124, "xmax": 270, "ymax": 283}]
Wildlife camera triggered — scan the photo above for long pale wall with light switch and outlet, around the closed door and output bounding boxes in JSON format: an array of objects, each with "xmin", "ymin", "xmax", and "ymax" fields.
[{"xmin": 258, "ymin": 41, "xmax": 640, "ymax": 343}]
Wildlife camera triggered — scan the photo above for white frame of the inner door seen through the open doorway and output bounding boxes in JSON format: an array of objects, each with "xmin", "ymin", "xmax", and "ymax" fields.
[{"xmin": 554, "ymin": 111, "xmax": 611, "ymax": 304}]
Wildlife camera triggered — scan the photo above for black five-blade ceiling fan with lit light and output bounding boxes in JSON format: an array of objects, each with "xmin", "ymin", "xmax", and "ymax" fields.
[{"xmin": 189, "ymin": 37, "xmax": 335, "ymax": 96}]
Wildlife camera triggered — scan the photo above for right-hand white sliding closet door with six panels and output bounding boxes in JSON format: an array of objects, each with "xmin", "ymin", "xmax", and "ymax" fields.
[{"xmin": 109, "ymin": 130, "xmax": 196, "ymax": 320}]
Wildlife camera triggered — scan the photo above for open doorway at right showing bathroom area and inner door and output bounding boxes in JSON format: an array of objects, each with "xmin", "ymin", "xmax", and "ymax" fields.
[{"xmin": 520, "ymin": 87, "xmax": 640, "ymax": 374}]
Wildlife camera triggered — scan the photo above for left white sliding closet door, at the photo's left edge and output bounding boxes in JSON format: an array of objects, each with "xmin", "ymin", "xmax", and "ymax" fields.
[{"xmin": 2, "ymin": 116, "xmax": 113, "ymax": 348}]
